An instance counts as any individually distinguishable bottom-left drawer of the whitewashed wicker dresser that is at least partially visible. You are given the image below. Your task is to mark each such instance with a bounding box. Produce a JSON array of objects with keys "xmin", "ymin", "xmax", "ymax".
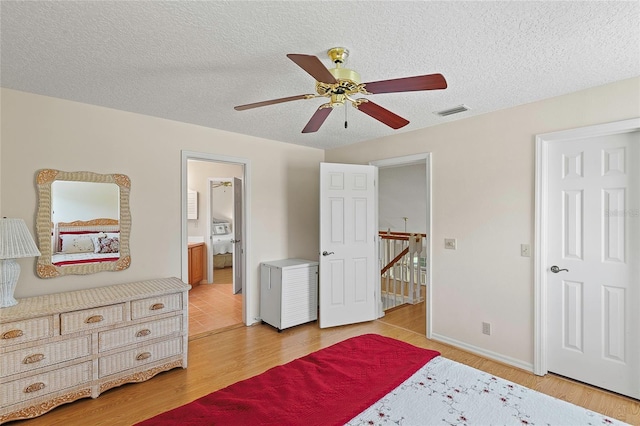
[{"xmin": 0, "ymin": 361, "xmax": 91, "ymax": 407}]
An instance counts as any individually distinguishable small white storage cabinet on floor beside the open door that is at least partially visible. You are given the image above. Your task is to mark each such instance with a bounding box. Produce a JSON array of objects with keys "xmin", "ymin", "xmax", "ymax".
[{"xmin": 260, "ymin": 259, "xmax": 318, "ymax": 332}]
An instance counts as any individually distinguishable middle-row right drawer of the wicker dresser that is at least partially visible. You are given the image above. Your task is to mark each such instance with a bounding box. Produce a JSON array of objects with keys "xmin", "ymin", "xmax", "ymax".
[{"xmin": 98, "ymin": 315, "xmax": 183, "ymax": 352}]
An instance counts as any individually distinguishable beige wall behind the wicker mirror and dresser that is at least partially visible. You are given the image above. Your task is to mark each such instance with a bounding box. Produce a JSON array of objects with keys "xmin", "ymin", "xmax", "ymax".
[{"xmin": 0, "ymin": 89, "xmax": 324, "ymax": 318}]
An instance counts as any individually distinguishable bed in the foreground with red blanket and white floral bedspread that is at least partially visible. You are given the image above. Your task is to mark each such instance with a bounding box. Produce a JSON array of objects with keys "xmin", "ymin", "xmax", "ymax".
[{"xmin": 138, "ymin": 334, "xmax": 625, "ymax": 426}]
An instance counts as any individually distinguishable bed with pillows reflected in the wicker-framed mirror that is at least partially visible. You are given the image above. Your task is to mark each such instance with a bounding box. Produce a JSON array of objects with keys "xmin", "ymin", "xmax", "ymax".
[{"xmin": 51, "ymin": 218, "xmax": 120, "ymax": 266}]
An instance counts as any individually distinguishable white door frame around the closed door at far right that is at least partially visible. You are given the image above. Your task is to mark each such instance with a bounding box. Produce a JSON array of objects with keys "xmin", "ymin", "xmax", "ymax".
[{"xmin": 533, "ymin": 118, "xmax": 640, "ymax": 376}]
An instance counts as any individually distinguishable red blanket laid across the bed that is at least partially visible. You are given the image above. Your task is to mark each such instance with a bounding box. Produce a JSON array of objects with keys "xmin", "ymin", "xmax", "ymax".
[{"xmin": 139, "ymin": 334, "xmax": 440, "ymax": 426}]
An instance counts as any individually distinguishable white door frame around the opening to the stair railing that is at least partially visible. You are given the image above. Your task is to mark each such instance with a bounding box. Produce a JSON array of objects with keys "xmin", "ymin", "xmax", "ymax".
[{"xmin": 369, "ymin": 152, "xmax": 433, "ymax": 339}]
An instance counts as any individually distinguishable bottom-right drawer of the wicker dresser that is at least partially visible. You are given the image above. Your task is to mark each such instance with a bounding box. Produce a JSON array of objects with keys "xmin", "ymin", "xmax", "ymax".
[{"xmin": 98, "ymin": 337, "xmax": 182, "ymax": 378}]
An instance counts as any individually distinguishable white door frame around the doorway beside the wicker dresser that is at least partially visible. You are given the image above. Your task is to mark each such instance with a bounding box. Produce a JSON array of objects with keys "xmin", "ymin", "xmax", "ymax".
[{"xmin": 180, "ymin": 150, "xmax": 253, "ymax": 325}]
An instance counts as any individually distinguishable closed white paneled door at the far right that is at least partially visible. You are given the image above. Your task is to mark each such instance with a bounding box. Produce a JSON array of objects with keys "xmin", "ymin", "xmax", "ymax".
[{"xmin": 545, "ymin": 131, "xmax": 640, "ymax": 398}]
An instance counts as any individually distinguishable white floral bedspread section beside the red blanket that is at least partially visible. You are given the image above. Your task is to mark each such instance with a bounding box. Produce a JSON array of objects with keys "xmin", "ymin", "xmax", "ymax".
[{"xmin": 347, "ymin": 356, "xmax": 626, "ymax": 426}]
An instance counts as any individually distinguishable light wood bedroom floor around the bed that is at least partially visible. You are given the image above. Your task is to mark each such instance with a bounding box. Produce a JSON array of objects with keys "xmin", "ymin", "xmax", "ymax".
[{"xmin": 11, "ymin": 305, "xmax": 640, "ymax": 426}]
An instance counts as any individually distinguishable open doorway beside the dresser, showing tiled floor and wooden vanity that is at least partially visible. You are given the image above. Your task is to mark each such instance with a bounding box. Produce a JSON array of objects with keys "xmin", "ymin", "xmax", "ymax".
[{"xmin": 182, "ymin": 151, "xmax": 249, "ymax": 338}]
